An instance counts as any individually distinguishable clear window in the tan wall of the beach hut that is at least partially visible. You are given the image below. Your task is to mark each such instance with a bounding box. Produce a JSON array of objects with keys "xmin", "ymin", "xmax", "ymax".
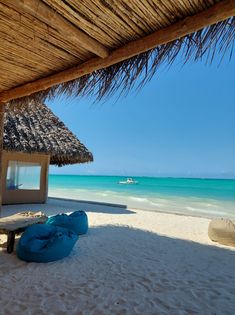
[{"xmin": 6, "ymin": 161, "xmax": 41, "ymax": 190}]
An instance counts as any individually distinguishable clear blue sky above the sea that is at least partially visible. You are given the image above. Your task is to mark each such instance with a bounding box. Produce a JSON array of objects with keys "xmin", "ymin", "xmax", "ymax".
[{"xmin": 47, "ymin": 58, "xmax": 235, "ymax": 178}]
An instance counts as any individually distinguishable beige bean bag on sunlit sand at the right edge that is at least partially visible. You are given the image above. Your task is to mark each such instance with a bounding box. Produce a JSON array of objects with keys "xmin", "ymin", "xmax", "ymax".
[{"xmin": 208, "ymin": 219, "xmax": 235, "ymax": 246}]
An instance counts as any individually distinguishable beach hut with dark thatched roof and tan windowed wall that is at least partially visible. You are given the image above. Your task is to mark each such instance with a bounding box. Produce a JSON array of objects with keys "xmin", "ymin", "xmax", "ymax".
[{"xmin": 1, "ymin": 101, "xmax": 93, "ymax": 204}]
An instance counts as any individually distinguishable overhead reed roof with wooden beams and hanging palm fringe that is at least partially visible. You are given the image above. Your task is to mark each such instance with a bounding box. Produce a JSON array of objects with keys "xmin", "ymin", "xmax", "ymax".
[{"xmin": 0, "ymin": 0, "xmax": 235, "ymax": 102}]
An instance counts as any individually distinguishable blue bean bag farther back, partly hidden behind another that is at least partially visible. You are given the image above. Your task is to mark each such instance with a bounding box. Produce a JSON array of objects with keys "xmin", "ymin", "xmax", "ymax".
[{"xmin": 46, "ymin": 211, "xmax": 88, "ymax": 235}]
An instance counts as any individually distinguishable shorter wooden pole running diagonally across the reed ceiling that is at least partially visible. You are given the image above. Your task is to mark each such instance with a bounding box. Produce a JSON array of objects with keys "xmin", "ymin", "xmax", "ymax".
[{"xmin": 4, "ymin": 0, "xmax": 109, "ymax": 58}]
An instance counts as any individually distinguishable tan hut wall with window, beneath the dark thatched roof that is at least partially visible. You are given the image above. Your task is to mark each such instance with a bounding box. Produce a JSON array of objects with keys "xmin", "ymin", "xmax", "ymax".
[{"xmin": 1, "ymin": 151, "xmax": 50, "ymax": 204}]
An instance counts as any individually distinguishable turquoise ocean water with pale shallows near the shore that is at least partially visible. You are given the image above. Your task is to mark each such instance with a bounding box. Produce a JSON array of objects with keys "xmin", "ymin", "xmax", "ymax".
[{"xmin": 49, "ymin": 175, "xmax": 235, "ymax": 218}]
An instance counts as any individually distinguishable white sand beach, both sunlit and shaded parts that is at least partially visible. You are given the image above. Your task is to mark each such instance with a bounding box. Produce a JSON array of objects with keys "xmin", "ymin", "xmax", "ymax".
[{"xmin": 0, "ymin": 200, "xmax": 235, "ymax": 315}]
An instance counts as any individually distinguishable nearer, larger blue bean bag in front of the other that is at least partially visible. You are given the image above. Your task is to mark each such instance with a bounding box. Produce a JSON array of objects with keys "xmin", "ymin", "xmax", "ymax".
[{"xmin": 16, "ymin": 224, "xmax": 78, "ymax": 262}]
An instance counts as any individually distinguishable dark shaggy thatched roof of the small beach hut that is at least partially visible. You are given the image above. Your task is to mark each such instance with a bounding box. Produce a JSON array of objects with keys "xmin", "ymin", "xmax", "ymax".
[{"xmin": 3, "ymin": 101, "xmax": 93, "ymax": 166}]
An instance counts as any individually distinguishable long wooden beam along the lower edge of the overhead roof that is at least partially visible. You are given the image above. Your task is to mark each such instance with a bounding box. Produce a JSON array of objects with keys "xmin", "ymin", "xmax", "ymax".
[{"xmin": 0, "ymin": 0, "xmax": 235, "ymax": 102}]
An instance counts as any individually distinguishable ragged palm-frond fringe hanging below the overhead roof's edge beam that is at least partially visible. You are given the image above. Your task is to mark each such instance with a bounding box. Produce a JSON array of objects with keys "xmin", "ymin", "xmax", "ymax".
[{"xmin": 11, "ymin": 17, "xmax": 235, "ymax": 105}]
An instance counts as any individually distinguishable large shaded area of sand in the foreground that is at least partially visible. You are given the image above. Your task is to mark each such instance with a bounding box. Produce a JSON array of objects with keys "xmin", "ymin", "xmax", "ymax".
[{"xmin": 0, "ymin": 225, "xmax": 235, "ymax": 315}]
